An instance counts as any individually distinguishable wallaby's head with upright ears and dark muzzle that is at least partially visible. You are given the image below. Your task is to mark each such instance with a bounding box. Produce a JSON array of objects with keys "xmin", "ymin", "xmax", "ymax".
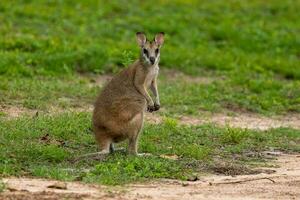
[{"xmin": 136, "ymin": 32, "xmax": 164, "ymax": 65}]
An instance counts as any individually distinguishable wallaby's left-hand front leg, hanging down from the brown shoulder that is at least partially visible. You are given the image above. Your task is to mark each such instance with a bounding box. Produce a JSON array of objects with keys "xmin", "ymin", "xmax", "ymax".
[{"xmin": 134, "ymin": 71, "xmax": 155, "ymax": 112}]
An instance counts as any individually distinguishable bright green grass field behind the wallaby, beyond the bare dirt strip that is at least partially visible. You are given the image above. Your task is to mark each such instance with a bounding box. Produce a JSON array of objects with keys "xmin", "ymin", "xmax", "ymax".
[{"xmin": 0, "ymin": 0, "xmax": 300, "ymax": 115}]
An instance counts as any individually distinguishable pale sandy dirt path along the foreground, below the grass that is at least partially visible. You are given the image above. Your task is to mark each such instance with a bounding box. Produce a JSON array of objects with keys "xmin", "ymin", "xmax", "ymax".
[{"xmin": 0, "ymin": 154, "xmax": 300, "ymax": 200}]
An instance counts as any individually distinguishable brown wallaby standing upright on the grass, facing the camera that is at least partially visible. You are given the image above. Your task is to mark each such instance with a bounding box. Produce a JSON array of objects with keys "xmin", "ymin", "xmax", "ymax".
[{"xmin": 76, "ymin": 32, "xmax": 164, "ymax": 161}]
